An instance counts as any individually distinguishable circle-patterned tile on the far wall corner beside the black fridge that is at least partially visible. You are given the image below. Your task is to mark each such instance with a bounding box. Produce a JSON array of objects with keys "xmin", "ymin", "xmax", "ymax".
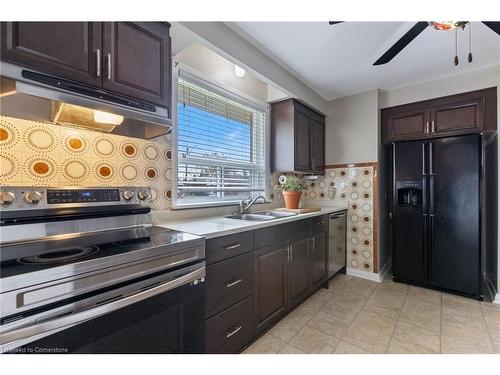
[{"xmin": 304, "ymin": 163, "xmax": 378, "ymax": 272}]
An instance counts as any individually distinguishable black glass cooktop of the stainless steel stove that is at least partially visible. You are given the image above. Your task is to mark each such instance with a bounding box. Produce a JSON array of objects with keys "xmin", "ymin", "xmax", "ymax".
[{"xmin": 0, "ymin": 226, "xmax": 203, "ymax": 279}]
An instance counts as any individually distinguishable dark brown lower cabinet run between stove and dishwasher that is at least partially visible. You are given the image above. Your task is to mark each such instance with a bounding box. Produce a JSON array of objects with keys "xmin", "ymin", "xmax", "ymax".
[{"xmin": 201, "ymin": 216, "xmax": 334, "ymax": 353}]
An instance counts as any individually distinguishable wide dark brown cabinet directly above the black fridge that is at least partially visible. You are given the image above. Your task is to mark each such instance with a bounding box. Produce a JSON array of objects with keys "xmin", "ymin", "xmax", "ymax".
[{"xmin": 381, "ymin": 88, "xmax": 497, "ymax": 143}]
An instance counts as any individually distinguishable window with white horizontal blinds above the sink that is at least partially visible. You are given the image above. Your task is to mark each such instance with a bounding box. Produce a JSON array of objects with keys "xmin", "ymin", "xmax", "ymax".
[{"xmin": 174, "ymin": 71, "xmax": 268, "ymax": 208}]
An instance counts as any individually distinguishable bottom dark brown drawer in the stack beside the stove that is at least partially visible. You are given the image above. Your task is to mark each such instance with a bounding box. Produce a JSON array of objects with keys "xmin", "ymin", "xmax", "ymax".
[{"xmin": 205, "ymin": 295, "xmax": 255, "ymax": 353}]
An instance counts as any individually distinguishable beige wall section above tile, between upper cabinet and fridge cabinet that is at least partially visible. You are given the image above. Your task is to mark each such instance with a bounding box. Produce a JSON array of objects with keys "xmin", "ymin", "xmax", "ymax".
[{"xmin": 325, "ymin": 90, "xmax": 379, "ymax": 164}]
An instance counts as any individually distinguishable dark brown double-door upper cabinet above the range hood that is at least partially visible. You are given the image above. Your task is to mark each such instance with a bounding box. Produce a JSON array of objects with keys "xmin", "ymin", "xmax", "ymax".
[{"xmin": 1, "ymin": 22, "xmax": 171, "ymax": 112}]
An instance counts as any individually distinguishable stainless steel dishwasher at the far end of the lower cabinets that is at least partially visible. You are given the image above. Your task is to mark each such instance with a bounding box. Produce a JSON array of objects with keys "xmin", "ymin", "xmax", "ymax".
[{"xmin": 328, "ymin": 211, "xmax": 347, "ymax": 278}]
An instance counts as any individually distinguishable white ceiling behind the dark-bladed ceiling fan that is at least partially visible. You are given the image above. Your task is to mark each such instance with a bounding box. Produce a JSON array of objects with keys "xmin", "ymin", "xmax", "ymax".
[{"xmin": 227, "ymin": 22, "xmax": 500, "ymax": 100}]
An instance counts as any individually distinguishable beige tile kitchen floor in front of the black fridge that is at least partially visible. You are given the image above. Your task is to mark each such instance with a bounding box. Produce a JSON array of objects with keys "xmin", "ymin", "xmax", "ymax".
[{"xmin": 244, "ymin": 274, "xmax": 500, "ymax": 354}]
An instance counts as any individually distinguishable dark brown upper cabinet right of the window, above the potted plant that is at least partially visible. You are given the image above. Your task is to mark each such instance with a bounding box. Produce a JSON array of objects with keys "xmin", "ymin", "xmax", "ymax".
[{"xmin": 271, "ymin": 99, "xmax": 325, "ymax": 174}]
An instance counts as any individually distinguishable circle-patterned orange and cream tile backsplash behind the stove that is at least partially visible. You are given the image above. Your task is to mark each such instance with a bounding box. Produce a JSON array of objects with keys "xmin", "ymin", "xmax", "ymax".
[{"xmin": 0, "ymin": 116, "xmax": 172, "ymax": 210}]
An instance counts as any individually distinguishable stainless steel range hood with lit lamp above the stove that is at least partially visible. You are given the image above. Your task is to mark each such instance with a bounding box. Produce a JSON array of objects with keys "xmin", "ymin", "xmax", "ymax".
[{"xmin": 0, "ymin": 62, "xmax": 172, "ymax": 139}]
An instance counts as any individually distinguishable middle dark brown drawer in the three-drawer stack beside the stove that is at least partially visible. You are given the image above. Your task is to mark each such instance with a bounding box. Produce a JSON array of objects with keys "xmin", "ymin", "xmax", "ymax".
[{"xmin": 205, "ymin": 252, "xmax": 254, "ymax": 318}]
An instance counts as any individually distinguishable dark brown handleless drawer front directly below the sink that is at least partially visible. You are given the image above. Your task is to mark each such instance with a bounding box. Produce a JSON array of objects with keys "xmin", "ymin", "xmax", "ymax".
[{"xmin": 255, "ymin": 219, "xmax": 311, "ymax": 249}]
